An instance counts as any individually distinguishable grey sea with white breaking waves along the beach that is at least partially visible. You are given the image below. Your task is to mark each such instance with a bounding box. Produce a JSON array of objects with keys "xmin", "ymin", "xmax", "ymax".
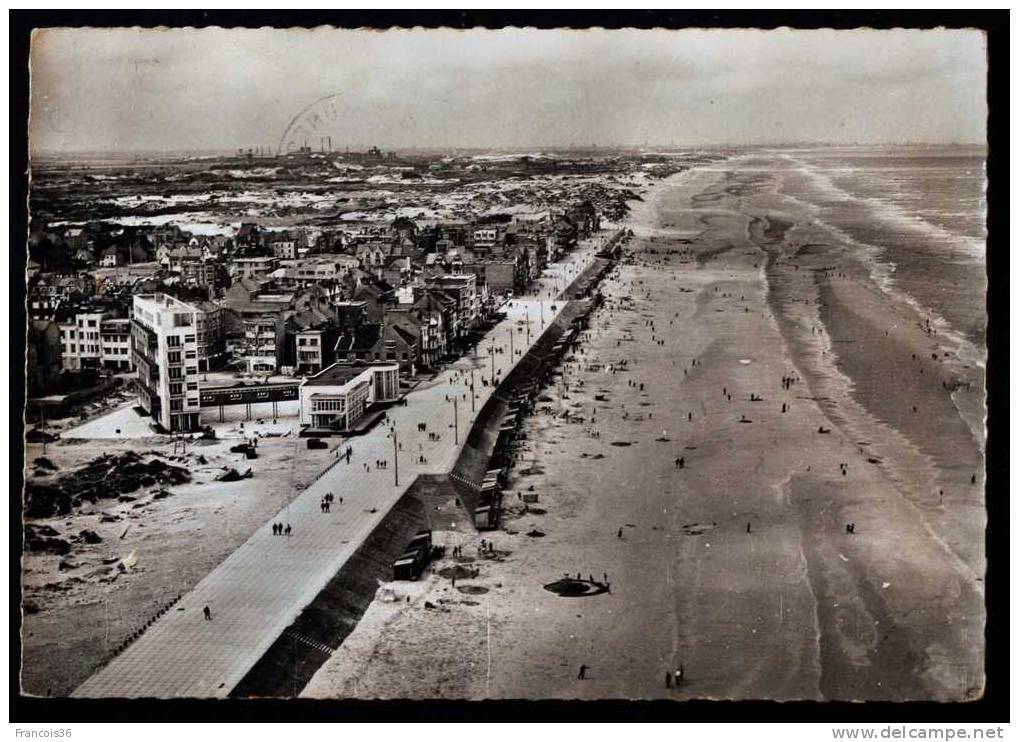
[{"xmin": 776, "ymin": 146, "xmax": 987, "ymax": 359}]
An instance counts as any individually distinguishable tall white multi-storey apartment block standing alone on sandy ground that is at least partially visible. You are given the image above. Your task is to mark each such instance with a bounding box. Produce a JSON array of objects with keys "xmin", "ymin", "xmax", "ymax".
[{"xmin": 131, "ymin": 294, "xmax": 200, "ymax": 431}]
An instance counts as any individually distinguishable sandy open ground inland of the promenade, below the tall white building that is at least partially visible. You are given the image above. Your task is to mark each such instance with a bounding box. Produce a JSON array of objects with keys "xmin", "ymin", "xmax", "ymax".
[{"xmin": 21, "ymin": 404, "xmax": 339, "ymax": 696}]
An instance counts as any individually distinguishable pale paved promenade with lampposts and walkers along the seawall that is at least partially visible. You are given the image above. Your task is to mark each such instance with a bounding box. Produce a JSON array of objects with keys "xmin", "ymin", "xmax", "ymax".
[{"xmin": 72, "ymin": 236, "xmax": 601, "ymax": 698}]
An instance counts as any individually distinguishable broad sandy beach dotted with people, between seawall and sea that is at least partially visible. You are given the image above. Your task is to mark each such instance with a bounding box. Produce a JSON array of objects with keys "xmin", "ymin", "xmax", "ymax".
[{"xmin": 305, "ymin": 161, "xmax": 984, "ymax": 700}]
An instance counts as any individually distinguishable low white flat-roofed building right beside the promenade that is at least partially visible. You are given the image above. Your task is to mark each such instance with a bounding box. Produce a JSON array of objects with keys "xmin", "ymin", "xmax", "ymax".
[{"xmin": 301, "ymin": 363, "xmax": 399, "ymax": 432}]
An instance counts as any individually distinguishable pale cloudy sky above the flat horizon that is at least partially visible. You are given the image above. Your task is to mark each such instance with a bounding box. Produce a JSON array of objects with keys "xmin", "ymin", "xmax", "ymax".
[{"xmin": 30, "ymin": 29, "xmax": 986, "ymax": 153}]
